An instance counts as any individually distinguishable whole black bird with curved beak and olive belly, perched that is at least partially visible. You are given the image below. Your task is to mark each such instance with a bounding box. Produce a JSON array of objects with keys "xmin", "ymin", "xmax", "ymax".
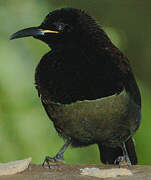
[{"xmin": 10, "ymin": 8, "xmax": 141, "ymax": 165}]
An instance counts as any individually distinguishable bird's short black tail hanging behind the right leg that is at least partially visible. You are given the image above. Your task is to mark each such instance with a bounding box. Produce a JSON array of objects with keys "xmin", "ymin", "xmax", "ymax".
[{"xmin": 98, "ymin": 138, "xmax": 137, "ymax": 165}]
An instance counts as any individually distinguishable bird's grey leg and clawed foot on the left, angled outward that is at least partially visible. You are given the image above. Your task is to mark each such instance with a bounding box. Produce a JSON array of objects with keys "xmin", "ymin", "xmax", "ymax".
[{"xmin": 42, "ymin": 139, "xmax": 71, "ymax": 168}]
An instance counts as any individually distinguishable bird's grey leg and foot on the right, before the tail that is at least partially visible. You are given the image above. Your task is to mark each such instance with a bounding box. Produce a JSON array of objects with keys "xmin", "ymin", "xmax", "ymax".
[{"xmin": 114, "ymin": 143, "xmax": 131, "ymax": 167}]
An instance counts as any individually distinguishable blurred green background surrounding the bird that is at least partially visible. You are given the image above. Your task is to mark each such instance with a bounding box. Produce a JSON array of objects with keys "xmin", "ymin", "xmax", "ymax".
[{"xmin": 0, "ymin": 0, "xmax": 151, "ymax": 165}]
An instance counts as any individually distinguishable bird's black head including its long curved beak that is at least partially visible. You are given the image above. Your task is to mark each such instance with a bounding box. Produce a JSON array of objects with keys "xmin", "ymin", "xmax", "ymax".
[{"xmin": 10, "ymin": 8, "xmax": 100, "ymax": 47}]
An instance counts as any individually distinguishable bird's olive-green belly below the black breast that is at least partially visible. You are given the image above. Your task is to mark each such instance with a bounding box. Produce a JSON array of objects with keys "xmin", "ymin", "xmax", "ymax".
[{"xmin": 45, "ymin": 90, "xmax": 141, "ymax": 146}]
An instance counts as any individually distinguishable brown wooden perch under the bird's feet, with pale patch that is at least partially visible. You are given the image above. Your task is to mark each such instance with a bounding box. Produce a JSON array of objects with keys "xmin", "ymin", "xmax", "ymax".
[{"xmin": 0, "ymin": 164, "xmax": 151, "ymax": 180}]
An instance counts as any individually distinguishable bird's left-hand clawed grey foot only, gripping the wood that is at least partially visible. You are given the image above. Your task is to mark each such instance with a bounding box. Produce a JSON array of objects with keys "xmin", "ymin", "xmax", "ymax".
[{"xmin": 42, "ymin": 154, "xmax": 65, "ymax": 169}]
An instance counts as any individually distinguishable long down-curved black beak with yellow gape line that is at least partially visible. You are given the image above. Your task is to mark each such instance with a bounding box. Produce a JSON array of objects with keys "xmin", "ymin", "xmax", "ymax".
[{"xmin": 10, "ymin": 27, "xmax": 59, "ymax": 40}]
